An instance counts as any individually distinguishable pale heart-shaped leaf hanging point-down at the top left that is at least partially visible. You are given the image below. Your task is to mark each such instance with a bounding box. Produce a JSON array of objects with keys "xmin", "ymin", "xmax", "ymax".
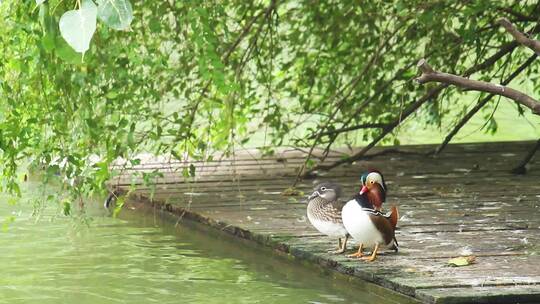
[{"xmin": 60, "ymin": 0, "xmax": 97, "ymax": 54}]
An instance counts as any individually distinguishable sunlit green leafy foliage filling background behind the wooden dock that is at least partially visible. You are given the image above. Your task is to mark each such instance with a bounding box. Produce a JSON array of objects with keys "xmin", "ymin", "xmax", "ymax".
[{"xmin": 0, "ymin": 0, "xmax": 540, "ymax": 204}]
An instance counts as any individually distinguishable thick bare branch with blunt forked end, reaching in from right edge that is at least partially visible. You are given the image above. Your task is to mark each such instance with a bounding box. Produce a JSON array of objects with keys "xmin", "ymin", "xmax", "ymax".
[{"xmin": 416, "ymin": 59, "xmax": 540, "ymax": 115}]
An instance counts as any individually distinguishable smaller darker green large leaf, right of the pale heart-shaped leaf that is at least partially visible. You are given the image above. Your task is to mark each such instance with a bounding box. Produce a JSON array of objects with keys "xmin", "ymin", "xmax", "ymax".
[{"xmin": 98, "ymin": 0, "xmax": 133, "ymax": 30}]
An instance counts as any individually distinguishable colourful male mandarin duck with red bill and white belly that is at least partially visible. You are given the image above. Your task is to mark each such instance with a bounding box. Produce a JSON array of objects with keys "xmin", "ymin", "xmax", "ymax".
[{"xmin": 342, "ymin": 172, "xmax": 399, "ymax": 261}]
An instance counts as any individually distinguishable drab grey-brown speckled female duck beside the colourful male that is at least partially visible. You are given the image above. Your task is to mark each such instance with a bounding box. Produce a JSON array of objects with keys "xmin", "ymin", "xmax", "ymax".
[{"xmin": 307, "ymin": 183, "xmax": 349, "ymax": 254}]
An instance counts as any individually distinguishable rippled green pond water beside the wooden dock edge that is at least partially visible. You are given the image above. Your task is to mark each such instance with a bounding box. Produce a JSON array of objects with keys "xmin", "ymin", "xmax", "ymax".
[{"xmin": 0, "ymin": 191, "xmax": 410, "ymax": 304}]
